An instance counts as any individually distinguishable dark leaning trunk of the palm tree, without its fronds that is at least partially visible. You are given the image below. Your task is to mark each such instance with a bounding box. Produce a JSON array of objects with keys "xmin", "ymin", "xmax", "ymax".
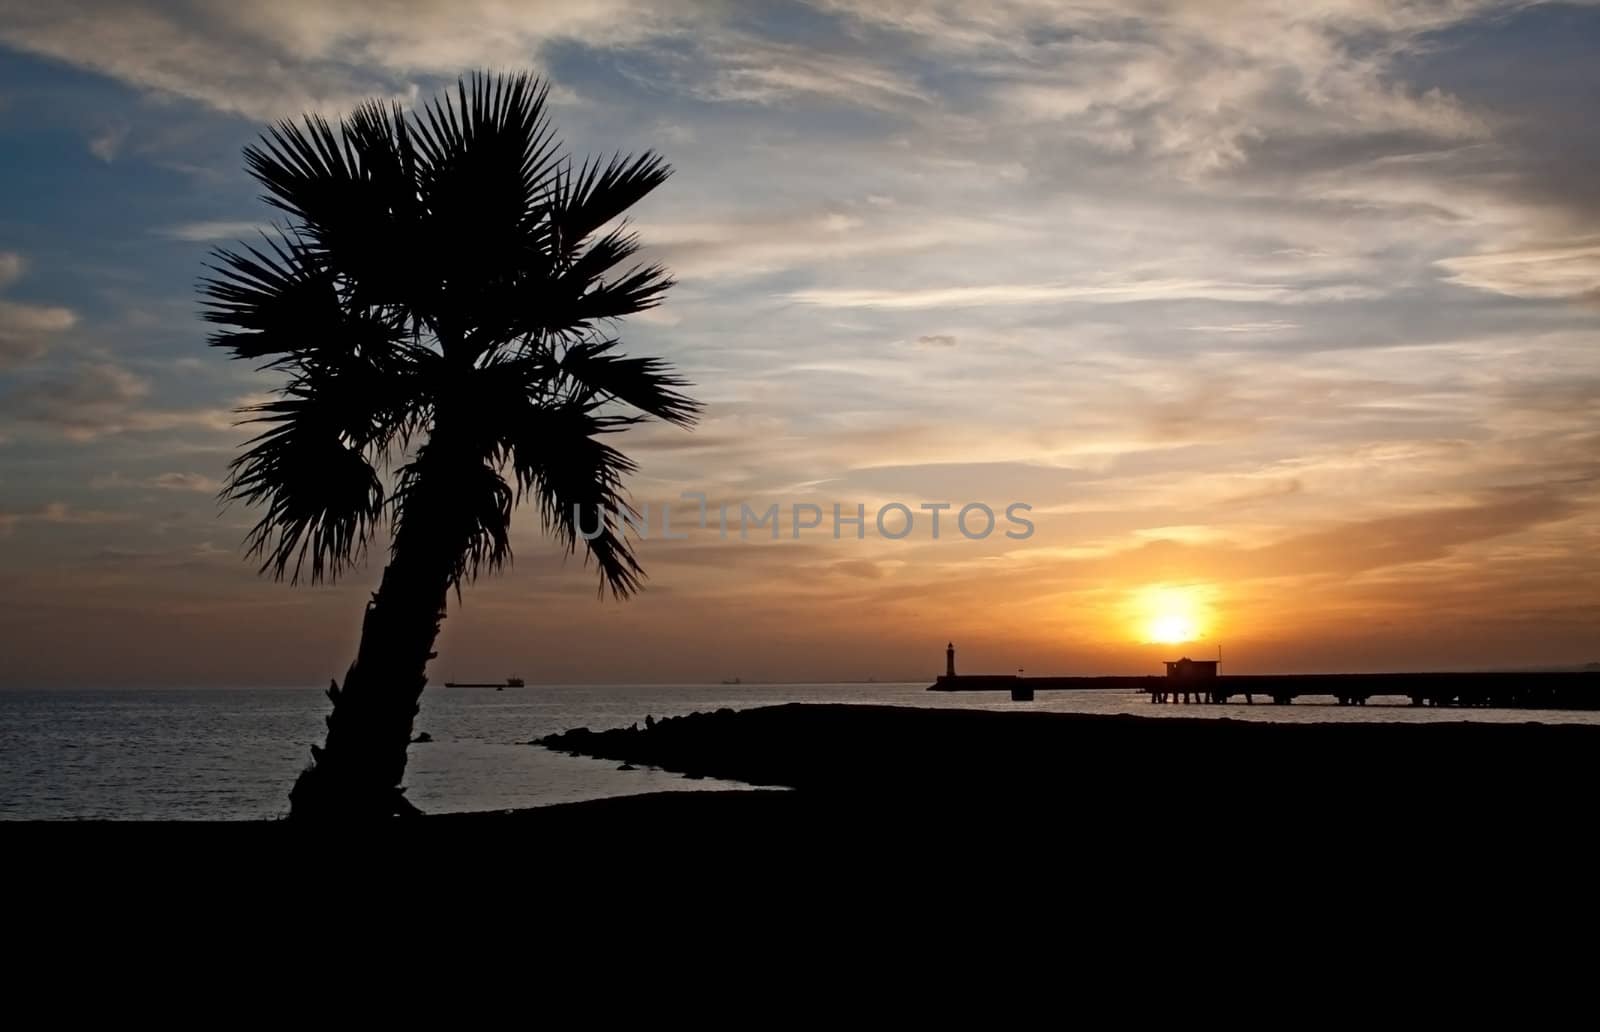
[{"xmin": 290, "ymin": 435, "xmax": 466, "ymax": 819}]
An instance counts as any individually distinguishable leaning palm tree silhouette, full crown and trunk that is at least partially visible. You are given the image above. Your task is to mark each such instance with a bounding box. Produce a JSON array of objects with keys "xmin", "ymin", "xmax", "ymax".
[{"xmin": 200, "ymin": 74, "xmax": 699, "ymax": 818}]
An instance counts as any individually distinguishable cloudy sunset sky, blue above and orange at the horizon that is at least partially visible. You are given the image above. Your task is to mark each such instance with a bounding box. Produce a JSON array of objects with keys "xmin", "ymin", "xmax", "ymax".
[{"xmin": 0, "ymin": 0, "xmax": 1600, "ymax": 686}]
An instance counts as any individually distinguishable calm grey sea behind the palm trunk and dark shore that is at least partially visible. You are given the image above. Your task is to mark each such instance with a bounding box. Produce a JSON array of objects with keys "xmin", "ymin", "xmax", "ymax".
[{"xmin": 0, "ymin": 682, "xmax": 1600, "ymax": 819}]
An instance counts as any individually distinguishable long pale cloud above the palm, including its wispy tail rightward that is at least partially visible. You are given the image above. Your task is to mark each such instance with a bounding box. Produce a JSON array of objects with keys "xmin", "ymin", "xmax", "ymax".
[{"xmin": 0, "ymin": 0, "xmax": 930, "ymax": 122}]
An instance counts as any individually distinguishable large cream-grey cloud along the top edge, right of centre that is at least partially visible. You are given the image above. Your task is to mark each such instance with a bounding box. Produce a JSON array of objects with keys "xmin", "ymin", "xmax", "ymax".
[{"xmin": 800, "ymin": 0, "xmax": 1488, "ymax": 187}]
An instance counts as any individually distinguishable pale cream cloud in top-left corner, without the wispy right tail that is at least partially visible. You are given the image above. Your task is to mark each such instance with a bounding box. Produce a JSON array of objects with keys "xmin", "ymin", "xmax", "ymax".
[{"xmin": 0, "ymin": 0, "xmax": 693, "ymax": 118}]
